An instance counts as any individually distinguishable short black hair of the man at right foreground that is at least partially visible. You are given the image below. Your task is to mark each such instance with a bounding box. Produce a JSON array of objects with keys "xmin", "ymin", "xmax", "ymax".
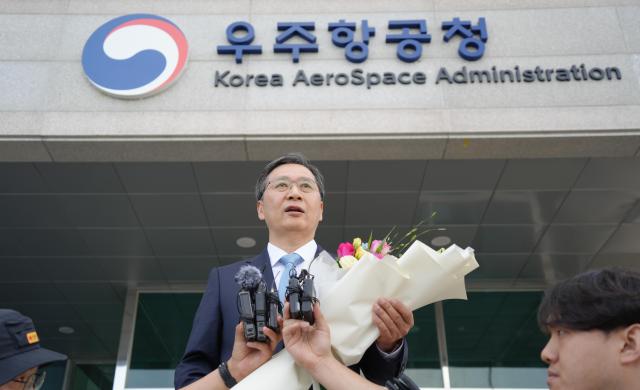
[{"xmin": 538, "ymin": 268, "xmax": 640, "ymax": 332}]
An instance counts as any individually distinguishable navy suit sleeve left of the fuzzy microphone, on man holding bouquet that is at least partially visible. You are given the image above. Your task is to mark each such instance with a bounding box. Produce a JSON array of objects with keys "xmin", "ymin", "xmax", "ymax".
[{"xmin": 174, "ymin": 268, "xmax": 222, "ymax": 389}]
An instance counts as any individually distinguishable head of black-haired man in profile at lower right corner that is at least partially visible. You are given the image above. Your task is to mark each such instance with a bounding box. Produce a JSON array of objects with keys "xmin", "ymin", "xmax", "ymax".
[{"xmin": 538, "ymin": 269, "xmax": 640, "ymax": 390}]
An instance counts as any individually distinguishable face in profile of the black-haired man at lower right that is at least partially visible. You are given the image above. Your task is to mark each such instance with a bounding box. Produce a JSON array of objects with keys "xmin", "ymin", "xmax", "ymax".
[{"xmin": 540, "ymin": 326, "xmax": 620, "ymax": 390}]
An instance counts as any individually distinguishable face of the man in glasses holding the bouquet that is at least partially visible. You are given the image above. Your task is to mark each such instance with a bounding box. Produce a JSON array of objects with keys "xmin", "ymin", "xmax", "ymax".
[{"xmin": 257, "ymin": 164, "xmax": 324, "ymax": 239}]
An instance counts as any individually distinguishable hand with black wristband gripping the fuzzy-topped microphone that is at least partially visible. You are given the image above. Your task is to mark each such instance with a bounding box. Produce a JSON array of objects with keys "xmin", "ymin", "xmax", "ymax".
[{"xmin": 227, "ymin": 317, "xmax": 282, "ymax": 382}]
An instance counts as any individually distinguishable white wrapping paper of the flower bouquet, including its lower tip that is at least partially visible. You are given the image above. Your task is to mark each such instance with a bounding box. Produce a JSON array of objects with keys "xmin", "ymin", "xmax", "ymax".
[{"xmin": 234, "ymin": 241, "xmax": 478, "ymax": 390}]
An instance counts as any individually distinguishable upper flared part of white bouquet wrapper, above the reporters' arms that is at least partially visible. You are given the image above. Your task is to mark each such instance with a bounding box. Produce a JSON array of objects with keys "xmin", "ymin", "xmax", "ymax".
[{"xmin": 321, "ymin": 241, "xmax": 478, "ymax": 365}]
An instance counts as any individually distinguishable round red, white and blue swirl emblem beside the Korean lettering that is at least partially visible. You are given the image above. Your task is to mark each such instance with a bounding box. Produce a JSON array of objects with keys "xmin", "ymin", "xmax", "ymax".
[{"xmin": 82, "ymin": 14, "xmax": 189, "ymax": 98}]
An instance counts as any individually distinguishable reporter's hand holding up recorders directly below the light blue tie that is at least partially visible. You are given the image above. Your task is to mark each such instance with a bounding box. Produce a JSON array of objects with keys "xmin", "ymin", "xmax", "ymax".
[{"xmin": 282, "ymin": 302, "xmax": 332, "ymax": 371}]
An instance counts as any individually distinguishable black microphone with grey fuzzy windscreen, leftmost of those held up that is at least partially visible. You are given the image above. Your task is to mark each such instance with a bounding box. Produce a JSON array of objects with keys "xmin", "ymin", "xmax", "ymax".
[{"xmin": 234, "ymin": 265, "xmax": 264, "ymax": 341}]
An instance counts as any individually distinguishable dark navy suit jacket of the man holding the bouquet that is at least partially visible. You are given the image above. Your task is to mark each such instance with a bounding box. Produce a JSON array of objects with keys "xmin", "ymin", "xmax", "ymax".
[{"xmin": 174, "ymin": 246, "xmax": 408, "ymax": 389}]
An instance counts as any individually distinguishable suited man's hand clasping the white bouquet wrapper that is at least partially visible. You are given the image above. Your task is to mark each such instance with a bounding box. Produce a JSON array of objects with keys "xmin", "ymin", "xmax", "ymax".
[{"xmin": 373, "ymin": 298, "xmax": 413, "ymax": 353}]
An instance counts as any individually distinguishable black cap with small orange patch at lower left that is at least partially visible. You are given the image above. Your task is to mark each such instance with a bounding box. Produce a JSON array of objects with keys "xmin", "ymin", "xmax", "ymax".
[{"xmin": 0, "ymin": 309, "xmax": 67, "ymax": 386}]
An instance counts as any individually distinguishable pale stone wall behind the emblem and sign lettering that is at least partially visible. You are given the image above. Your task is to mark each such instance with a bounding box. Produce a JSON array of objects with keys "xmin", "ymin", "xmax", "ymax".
[{"xmin": 0, "ymin": 0, "xmax": 640, "ymax": 161}]
